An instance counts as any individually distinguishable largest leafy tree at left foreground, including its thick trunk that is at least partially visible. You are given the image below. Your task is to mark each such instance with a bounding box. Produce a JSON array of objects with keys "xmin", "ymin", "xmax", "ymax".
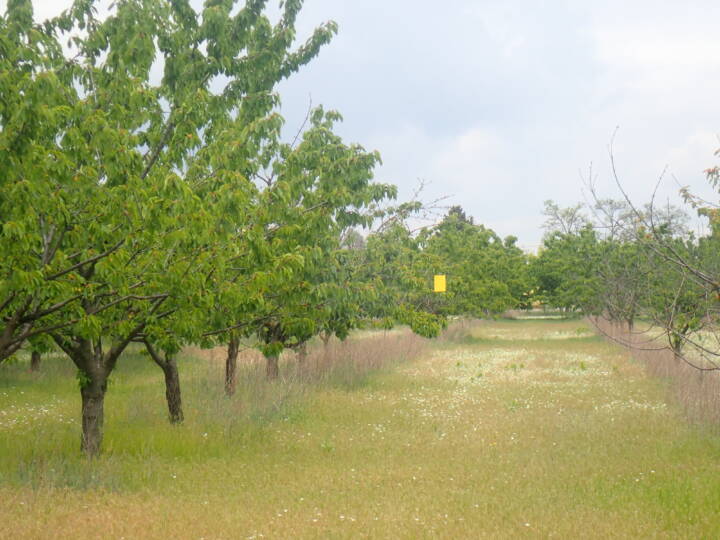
[{"xmin": 0, "ymin": 0, "xmax": 335, "ymax": 455}]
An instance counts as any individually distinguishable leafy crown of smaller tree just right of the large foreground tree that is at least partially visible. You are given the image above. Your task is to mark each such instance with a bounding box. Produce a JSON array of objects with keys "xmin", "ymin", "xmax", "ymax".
[{"xmin": 219, "ymin": 108, "xmax": 395, "ymax": 355}]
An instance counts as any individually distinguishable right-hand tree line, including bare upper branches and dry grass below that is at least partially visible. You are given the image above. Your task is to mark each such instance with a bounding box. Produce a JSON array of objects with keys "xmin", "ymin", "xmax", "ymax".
[{"xmin": 530, "ymin": 154, "xmax": 720, "ymax": 371}]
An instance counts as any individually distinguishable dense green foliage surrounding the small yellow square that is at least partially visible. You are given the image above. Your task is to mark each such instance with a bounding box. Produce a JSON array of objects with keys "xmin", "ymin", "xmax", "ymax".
[{"xmin": 355, "ymin": 207, "xmax": 530, "ymax": 337}]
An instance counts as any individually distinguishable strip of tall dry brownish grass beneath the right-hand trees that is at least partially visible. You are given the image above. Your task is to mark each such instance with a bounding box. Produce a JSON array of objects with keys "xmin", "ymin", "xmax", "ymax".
[{"xmin": 591, "ymin": 318, "xmax": 720, "ymax": 431}]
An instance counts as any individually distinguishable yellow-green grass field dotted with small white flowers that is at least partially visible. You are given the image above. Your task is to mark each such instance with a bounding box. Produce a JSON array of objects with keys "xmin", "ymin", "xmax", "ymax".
[{"xmin": 0, "ymin": 320, "xmax": 720, "ymax": 539}]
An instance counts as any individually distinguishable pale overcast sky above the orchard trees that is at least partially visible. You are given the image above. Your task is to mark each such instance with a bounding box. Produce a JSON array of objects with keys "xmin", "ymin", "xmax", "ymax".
[{"xmin": 15, "ymin": 0, "xmax": 720, "ymax": 248}]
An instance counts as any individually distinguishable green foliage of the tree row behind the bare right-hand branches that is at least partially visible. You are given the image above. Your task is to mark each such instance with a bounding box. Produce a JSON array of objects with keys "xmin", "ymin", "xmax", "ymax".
[{"xmin": 532, "ymin": 200, "xmax": 719, "ymax": 354}]
